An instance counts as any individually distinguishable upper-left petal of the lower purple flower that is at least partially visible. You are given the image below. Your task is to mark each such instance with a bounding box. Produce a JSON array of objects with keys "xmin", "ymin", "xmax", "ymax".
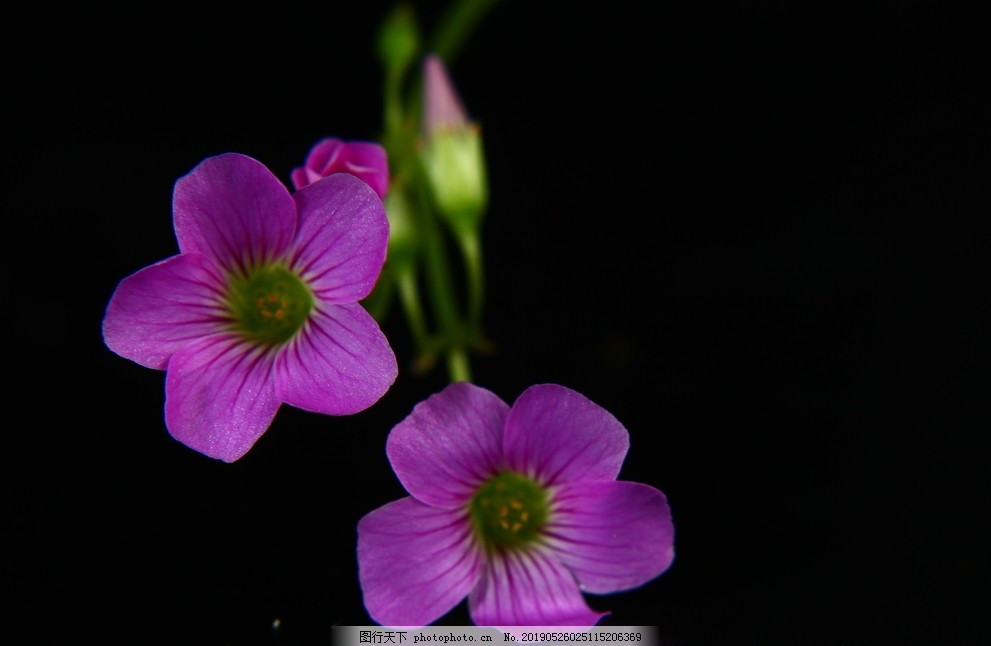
[{"xmin": 385, "ymin": 382, "xmax": 509, "ymax": 509}]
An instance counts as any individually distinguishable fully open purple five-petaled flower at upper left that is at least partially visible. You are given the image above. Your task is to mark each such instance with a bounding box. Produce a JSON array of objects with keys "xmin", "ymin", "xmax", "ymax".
[{"xmin": 103, "ymin": 154, "xmax": 397, "ymax": 462}]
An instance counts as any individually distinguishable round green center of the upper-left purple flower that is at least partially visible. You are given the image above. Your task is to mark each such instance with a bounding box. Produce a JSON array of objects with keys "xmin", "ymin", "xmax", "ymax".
[{"xmin": 227, "ymin": 264, "xmax": 313, "ymax": 345}]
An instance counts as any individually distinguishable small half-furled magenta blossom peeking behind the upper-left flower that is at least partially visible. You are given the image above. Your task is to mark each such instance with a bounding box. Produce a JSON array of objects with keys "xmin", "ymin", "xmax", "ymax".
[{"xmin": 292, "ymin": 138, "xmax": 389, "ymax": 199}]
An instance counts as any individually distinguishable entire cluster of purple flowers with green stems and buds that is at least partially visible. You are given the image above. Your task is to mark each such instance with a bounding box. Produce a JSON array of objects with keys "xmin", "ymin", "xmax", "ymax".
[{"xmin": 103, "ymin": 0, "xmax": 674, "ymax": 627}]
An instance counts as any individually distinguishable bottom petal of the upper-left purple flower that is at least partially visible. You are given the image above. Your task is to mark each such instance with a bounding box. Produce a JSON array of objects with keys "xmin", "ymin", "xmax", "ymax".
[{"xmin": 165, "ymin": 334, "xmax": 280, "ymax": 462}]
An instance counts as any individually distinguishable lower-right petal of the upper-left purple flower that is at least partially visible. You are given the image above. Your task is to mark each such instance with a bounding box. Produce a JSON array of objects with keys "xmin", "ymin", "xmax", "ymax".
[{"xmin": 275, "ymin": 303, "xmax": 398, "ymax": 415}]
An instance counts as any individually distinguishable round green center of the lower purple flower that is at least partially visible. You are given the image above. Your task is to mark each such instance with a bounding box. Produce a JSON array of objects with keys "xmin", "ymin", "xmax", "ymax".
[{"xmin": 469, "ymin": 471, "xmax": 550, "ymax": 550}]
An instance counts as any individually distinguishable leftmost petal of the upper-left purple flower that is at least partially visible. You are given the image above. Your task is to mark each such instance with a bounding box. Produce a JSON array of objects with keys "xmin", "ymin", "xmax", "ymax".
[{"xmin": 103, "ymin": 254, "xmax": 224, "ymax": 370}]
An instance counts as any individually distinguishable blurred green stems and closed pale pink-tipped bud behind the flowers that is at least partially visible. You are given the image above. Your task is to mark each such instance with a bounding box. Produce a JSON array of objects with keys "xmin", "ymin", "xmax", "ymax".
[{"xmin": 370, "ymin": 0, "xmax": 496, "ymax": 382}]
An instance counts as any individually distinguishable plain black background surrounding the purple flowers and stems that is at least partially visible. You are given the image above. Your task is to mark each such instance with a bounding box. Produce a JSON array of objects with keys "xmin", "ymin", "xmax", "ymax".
[{"xmin": 11, "ymin": 1, "xmax": 991, "ymax": 646}]
